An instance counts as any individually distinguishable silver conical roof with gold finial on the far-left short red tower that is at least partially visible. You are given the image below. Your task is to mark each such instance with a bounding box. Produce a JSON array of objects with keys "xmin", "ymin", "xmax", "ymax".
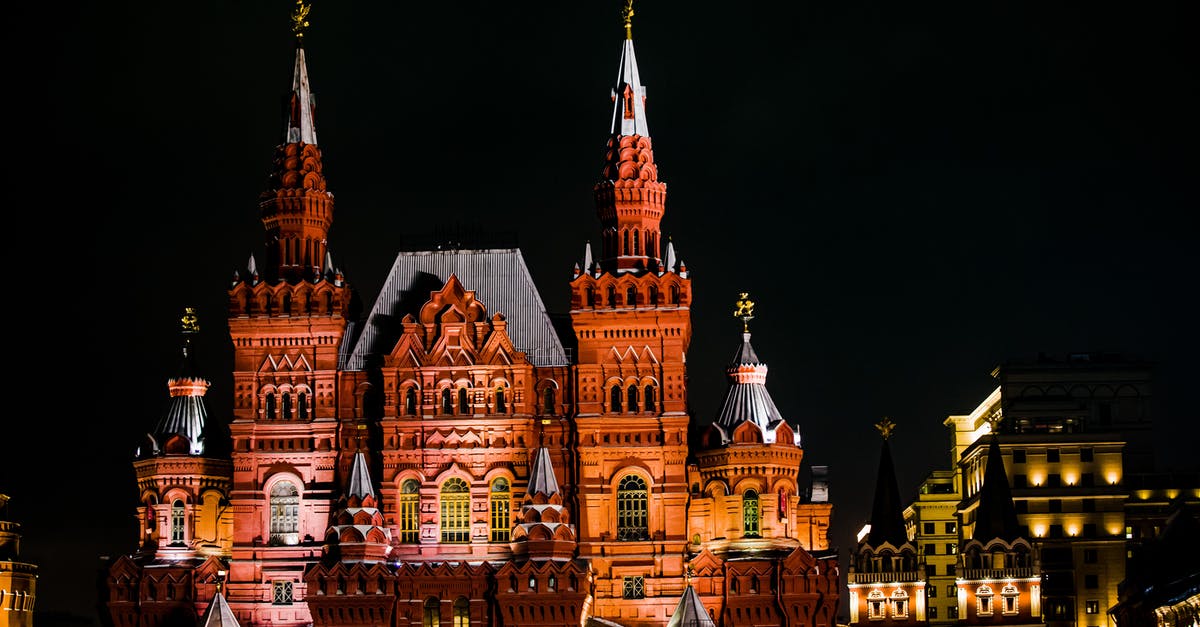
[{"xmin": 142, "ymin": 307, "xmax": 210, "ymax": 455}]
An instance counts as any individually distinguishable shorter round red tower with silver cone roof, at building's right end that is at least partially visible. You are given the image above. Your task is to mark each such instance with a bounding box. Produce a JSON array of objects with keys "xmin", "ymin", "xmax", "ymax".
[{"xmin": 688, "ymin": 293, "xmax": 839, "ymax": 626}]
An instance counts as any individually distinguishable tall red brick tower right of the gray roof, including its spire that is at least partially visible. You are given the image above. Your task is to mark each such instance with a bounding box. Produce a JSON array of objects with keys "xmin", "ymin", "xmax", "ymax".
[{"xmin": 570, "ymin": 0, "xmax": 691, "ymax": 625}]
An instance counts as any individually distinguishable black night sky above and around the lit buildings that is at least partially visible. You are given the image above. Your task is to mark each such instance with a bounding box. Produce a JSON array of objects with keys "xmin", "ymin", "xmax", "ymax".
[{"xmin": 11, "ymin": 0, "xmax": 1200, "ymax": 614}]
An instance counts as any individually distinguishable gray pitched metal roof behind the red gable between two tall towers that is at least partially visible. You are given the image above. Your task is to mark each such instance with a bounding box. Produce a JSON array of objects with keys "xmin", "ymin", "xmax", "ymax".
[{"xmin": 341, "ymin": 249, "xmax": 569, "ymax": 370}]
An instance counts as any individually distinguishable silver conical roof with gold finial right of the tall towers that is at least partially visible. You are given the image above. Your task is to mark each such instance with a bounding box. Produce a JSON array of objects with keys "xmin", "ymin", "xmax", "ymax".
[{"xmin": 710, "ymin": 292, "xmax": 800, "ymax": 446}]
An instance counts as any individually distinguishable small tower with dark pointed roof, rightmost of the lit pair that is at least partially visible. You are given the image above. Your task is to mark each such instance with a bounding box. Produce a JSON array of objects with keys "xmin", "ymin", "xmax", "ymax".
[{"xmin": 958, "ymin": 417, "xmax": 1043, "ymax": 625}]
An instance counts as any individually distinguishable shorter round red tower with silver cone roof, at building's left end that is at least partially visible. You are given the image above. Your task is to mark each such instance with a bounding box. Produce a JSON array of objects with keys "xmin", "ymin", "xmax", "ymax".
[{"xmin": 108, "ymin": 307, "xmax": 233, "ymax": 627}]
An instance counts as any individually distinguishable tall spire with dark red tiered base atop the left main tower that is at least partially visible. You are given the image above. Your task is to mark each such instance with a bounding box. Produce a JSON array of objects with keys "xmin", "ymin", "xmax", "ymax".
[{"xmin": 259, "ymin": 0, "xmax": 334, "ymax": 282}]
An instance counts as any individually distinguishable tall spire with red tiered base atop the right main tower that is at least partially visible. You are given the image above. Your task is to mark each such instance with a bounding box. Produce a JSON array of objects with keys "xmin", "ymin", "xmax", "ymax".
[{"xmin": 593, "ymin": 0, "xmax": 667, "ymax": 273}]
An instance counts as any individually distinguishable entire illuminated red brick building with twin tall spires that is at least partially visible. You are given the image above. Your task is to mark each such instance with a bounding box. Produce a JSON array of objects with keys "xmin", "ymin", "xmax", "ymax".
[{"xmin": 108, "ymin": 4, "xmax": 839, "ymax": 627}]
